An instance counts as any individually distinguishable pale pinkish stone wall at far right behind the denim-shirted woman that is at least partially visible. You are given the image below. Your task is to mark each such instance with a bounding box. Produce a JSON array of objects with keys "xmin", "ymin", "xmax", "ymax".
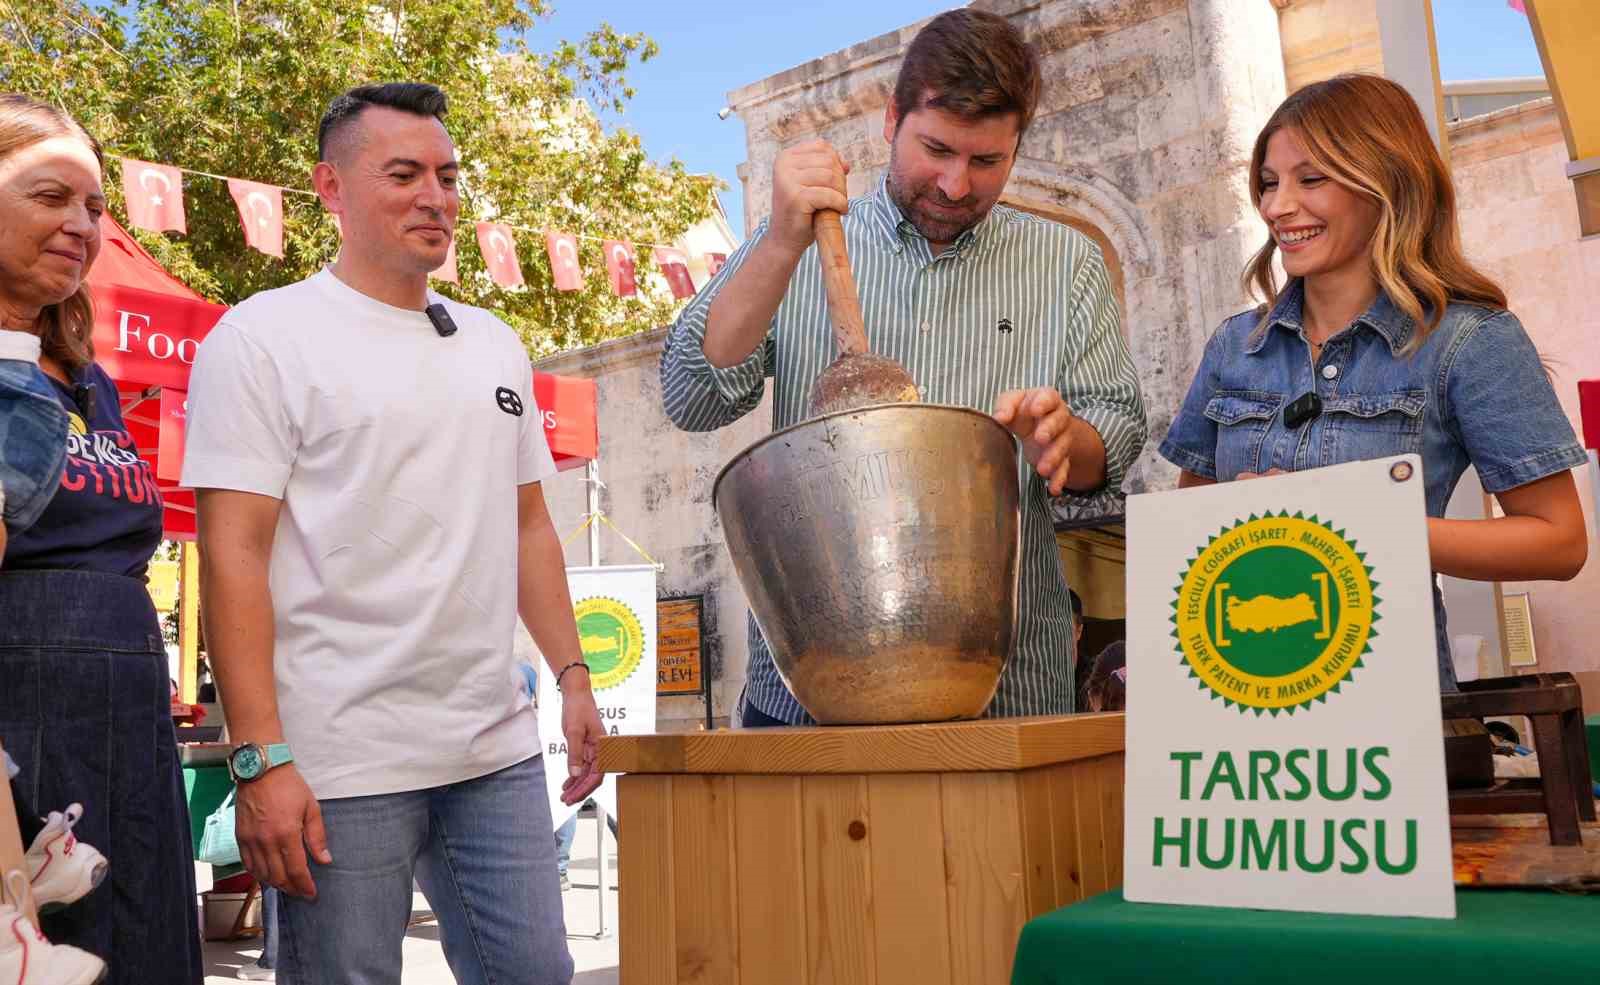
[{"xmin": 1450, "ymin": 99, "xmax": 1600, "ymax": 672}]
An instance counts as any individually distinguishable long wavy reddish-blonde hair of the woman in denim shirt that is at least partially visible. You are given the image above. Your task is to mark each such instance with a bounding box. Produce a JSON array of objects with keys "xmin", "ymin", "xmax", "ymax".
[{"xmin": 1243, "ymin": 75, "xmax": 1506, "ymax": 352}]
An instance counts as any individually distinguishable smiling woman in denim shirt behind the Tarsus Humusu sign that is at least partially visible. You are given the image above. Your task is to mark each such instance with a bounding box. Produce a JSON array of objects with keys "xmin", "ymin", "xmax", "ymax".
[{"xmin": 1162, "ymin": 75, "xmax": 1589, "ymax": 691}]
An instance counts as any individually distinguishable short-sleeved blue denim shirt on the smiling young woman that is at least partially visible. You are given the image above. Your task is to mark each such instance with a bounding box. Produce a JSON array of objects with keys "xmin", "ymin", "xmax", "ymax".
[{"xmin": 1160, "ymin": 280, "xmax": 1586, "ymax": 691}]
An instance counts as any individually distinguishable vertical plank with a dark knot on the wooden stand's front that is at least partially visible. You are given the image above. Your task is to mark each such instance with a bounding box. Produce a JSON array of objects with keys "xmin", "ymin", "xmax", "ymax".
[{"xmin": 800, "ymin": 776, "xmax": 877, "ymax": 985}]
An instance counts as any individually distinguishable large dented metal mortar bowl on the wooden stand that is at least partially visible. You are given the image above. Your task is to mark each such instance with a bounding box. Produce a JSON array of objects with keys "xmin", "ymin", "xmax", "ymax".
[{"xmin": 712, "ymin": 403, "xmax": 1021, "ymax": 724}]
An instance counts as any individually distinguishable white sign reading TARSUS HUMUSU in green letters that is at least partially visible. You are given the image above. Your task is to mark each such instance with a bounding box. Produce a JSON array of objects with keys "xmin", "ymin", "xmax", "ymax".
[{"xmin": 1125, "ymin": 456, "xmax": 1456, "ymax": 916}]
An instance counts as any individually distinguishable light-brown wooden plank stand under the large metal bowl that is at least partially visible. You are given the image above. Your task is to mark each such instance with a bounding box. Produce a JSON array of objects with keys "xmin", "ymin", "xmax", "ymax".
[{"xmin": 600, "ymin": 713, "xmax": 1123, "ymax": 985}]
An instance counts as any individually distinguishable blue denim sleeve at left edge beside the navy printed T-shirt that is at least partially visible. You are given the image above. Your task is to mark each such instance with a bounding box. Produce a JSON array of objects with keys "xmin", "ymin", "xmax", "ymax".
[{"xmin": 0, "ymin": 358, "xmax": 67, "ymax": 534}]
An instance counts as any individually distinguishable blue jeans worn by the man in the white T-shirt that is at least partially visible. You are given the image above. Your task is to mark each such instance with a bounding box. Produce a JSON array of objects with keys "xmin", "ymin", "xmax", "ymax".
[{"xmin": 277, "ymin": 756, "xmax": 573, "ymax": 985}]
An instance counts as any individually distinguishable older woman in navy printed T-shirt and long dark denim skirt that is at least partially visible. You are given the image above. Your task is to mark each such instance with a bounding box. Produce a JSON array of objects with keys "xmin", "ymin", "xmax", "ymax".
[{"xmin": 0, "ymin": 96, "xmax": 203, "ymax": 985}]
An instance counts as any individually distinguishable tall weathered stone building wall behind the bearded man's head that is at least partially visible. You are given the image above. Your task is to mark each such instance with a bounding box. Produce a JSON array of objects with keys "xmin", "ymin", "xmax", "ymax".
[{"xmin": 730, "ymin": 0, "xmax": 1283, "ymax": 491}]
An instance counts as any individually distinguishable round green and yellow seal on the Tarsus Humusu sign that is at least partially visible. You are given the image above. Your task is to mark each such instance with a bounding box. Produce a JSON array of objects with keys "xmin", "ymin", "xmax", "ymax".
[{"xmin": 1171, "ymin": 512, "xmax": 1381, "ymax": 715}]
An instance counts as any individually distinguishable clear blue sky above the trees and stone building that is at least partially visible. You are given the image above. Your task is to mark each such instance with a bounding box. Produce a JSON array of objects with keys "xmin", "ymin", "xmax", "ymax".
[{"xmin": 530, "ymin": 0, "xmax": 1541, "ymax": 232}]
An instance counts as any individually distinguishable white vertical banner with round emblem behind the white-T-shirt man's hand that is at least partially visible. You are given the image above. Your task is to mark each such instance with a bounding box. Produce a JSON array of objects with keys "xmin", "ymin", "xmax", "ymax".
[{"xmin": 539, "ymin": 564, "xmax": 656, "ymax": 828}]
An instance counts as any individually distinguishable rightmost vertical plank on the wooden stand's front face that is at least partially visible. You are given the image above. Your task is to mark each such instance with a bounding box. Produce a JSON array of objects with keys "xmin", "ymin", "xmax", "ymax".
[{"xmin": 939, "ymin": 772, "xmax": 1027, "ymax": 985}]
